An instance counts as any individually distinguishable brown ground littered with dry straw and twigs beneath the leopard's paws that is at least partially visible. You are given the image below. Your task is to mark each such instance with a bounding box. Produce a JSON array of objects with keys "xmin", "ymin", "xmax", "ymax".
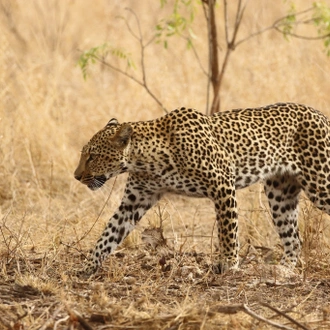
[{"xmin": 0, "ymin": 222, "xmax": 330, "ymax": 329}]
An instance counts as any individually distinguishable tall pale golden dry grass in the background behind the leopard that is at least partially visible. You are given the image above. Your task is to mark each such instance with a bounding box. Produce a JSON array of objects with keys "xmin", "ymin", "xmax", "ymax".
[{"xmin": 0, "ymin": 0, "xmax": 330, "ymax": 282}]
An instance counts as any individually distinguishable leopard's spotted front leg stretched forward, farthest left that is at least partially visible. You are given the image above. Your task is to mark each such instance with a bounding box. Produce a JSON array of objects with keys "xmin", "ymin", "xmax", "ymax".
[{"xmin": 83, "ymin": 178, "xmax": 161, "ymax": 275}]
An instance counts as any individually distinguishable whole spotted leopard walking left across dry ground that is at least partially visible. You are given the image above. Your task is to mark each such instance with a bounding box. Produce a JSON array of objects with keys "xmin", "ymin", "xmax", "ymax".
[{"xmin": 74, "ymin": 103, "xmax": 330, "ymax": 274}]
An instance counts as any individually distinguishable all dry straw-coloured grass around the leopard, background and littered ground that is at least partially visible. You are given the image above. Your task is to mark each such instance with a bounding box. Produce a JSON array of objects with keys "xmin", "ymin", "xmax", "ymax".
[{"xmin": 0, "ymin": 0, "xmax": 330, "ymax": 329}]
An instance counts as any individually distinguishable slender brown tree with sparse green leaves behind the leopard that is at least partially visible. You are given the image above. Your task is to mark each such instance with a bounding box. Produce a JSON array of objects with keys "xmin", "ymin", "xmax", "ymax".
[{"xmin": 79, "ymin": 0, "xmax": 330, "ymax": 114}]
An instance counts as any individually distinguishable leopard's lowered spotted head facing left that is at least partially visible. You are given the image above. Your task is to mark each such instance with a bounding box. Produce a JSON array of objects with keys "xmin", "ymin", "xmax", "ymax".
[{"xmin": 74, "ymin": 118, "xmax": 133, "ymax": 190}]
